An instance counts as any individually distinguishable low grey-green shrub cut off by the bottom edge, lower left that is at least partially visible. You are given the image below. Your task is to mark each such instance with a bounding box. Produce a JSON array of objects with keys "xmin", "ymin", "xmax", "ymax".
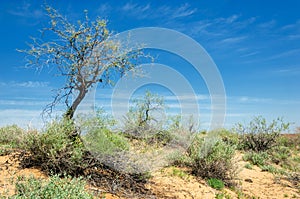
[{"xmin": 10, "ymin": 175, "xmax": 93, "ymax": 199}]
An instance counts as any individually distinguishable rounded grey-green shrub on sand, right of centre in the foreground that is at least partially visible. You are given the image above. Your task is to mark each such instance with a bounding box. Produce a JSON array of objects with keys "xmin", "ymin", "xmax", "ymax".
[{"xmin": 189, "ymin": 136, "xmax": 236, "ymax": 183}]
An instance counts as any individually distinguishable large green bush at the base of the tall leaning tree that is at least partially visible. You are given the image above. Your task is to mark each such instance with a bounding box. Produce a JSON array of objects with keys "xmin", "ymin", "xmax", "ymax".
[{"xmin": 23, "ymin": 120, "xmax": 86, "ymax": 175}]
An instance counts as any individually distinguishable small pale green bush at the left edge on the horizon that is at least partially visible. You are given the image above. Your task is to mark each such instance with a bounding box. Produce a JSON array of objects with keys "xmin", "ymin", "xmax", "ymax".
[{"xmin": 0, "ymin": 124, "xmax": 25, "ymax": 147}]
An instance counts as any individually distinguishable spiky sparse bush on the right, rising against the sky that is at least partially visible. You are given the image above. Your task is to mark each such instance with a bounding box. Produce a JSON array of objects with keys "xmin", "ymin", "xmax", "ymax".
[{"xmin": 234, "ymin": 116, "xmax": 289, "ymax": 152}]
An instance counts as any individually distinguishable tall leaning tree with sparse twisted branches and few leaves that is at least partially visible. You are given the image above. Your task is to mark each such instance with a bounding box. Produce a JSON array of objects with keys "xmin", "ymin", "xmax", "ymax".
[{"xmin": 21, "ymin": 6, "xmax": 143, "ymax": 119}]
